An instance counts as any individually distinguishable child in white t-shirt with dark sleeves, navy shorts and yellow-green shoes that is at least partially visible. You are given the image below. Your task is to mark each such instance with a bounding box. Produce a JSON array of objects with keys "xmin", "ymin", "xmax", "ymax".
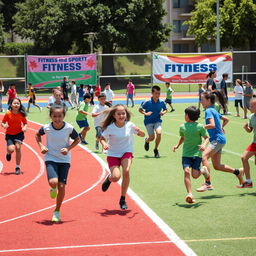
[{"xmin": 36, "ymin": 105, "xmax": 79, "ymax": 222}]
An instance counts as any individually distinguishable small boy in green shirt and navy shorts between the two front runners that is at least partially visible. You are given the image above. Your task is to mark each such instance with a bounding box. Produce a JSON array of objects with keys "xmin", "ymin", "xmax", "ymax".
[{"xmin": 76, "ymin": 93, "xmax": 92, "ymax": 144}]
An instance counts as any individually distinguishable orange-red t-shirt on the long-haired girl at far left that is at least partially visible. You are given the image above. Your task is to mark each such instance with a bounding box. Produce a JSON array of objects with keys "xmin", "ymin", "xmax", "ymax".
[{"xmin": 2, "ymin": 111, "xmax": 27, "ymax": 135}]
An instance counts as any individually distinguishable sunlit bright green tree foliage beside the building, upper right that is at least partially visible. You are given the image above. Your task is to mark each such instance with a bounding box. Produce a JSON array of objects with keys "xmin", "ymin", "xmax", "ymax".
[{"xmin": 187, "ymin": 0, "xmax": 256, "ymax": 48}]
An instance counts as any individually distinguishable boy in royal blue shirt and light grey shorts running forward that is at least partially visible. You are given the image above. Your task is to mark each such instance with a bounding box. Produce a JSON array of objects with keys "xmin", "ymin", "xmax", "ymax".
[{"xmin": 139, "ymin": 85, "xmax": 167, "ymax": 158}]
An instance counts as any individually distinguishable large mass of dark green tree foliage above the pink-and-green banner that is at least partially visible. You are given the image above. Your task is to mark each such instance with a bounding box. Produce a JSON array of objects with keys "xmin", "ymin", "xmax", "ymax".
[{"xmin": 14, "ymin": 0, "xmax": 171, "ymax": 53}]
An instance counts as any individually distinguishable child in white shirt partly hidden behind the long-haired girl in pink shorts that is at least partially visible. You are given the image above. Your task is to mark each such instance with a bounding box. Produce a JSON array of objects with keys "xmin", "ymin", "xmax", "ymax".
[{"xmin": 92, "ymin": 93, "xmax": 108, "ymax": 150}]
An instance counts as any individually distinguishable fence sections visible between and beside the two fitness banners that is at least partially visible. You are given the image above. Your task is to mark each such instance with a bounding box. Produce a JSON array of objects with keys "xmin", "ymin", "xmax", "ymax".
[{"xmin": 0, "ymin": 51, "xmax": 256, "ymax": 92}]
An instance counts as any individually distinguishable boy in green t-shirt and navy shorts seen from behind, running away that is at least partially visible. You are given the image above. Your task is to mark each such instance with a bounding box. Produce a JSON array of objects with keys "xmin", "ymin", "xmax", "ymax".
[{"xmin": 173, "ymin": 106, "xmax": 209, "ymax": 204}]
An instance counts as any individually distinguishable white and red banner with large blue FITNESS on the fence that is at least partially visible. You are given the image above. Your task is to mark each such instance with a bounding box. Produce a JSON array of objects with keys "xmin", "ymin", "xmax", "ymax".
[{"xmin": 153, "ymin": 52, "xmax": 233, "ymax": 84}]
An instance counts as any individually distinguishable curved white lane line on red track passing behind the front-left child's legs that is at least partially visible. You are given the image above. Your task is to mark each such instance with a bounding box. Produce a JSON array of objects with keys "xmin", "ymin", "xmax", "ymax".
[{"xmin": 0, "ymin": 126, "xmax": 106, "ymax": 225}]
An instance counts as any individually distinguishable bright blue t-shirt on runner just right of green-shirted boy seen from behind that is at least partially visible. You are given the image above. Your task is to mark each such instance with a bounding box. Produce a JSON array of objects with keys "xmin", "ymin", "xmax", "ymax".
[{"xmin": 205, "ymin": 106, "xmax": 226, "ymax": 144}]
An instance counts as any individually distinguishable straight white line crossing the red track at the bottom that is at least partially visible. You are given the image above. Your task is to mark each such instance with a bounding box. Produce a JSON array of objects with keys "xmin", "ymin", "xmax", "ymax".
[{"xmin": 0, "ymin": 240, "xmax": 173, "ymax": 253}]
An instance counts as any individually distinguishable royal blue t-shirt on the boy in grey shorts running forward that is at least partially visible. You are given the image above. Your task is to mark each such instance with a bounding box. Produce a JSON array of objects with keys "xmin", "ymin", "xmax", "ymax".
[{"xmin": 140, "ymin": 98, "xmax": 166, "ymax": 125}]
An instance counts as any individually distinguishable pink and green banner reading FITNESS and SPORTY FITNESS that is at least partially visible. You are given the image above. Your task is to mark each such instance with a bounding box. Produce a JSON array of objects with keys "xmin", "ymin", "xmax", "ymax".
[{"xmin": 27, "ymin": 54, "xmax": 97, "ymax": 88}]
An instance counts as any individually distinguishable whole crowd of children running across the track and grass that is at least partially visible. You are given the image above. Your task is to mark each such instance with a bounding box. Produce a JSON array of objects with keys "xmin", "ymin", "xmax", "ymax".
[{"xmin": 0, "ymin": 71, "xmax": 256, "ymax": 221}]
